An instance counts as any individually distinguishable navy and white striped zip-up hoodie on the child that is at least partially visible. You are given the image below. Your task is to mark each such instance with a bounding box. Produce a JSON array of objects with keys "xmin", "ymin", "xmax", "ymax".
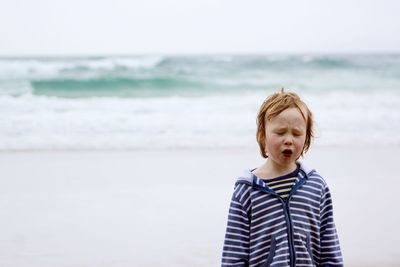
[{"xmin": 222, "ymin": 165, "xmax": 343, "ymax": 267}]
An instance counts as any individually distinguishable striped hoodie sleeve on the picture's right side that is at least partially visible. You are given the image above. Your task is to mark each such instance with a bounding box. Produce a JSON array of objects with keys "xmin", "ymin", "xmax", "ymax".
[{"xmin": 317, "ymin": 185, "xmax": 343, "ymax": 267}]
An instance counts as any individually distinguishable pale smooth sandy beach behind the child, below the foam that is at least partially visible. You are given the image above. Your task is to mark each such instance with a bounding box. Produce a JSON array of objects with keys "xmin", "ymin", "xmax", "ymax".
[{"xmin": 0, "ymin": 146, "xmax": 400, "ymax": 267}]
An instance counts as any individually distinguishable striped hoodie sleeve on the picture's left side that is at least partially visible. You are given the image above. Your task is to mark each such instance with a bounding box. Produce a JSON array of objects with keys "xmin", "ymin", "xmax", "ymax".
[{"xmin": 221, "ymin": 188, "xmax": 250, "ymax": 267}]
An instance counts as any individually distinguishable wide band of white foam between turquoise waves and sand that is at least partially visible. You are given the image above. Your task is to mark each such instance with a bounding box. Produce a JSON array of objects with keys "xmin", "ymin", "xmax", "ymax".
[{"xmin": 0, "ymin": 92, "xmax": 400, "ymax": 150}]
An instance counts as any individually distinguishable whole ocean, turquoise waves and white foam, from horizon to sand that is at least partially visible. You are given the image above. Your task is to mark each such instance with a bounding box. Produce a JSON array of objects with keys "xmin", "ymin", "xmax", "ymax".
[{"xmin": 0, "ymin": 55, "xmax": 400, "ymax": 151}]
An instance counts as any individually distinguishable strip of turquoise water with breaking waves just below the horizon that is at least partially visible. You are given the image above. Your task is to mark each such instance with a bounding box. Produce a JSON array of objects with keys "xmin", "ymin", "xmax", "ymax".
[{"xmin": 0, "ymin": 55, "xmax": 400, "ymax": 98}]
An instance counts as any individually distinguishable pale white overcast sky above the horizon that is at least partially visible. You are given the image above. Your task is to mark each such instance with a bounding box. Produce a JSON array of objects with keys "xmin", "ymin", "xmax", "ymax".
[{"xmin": 0, "ymin": 0, "xmax": 400, "ymax": 56}]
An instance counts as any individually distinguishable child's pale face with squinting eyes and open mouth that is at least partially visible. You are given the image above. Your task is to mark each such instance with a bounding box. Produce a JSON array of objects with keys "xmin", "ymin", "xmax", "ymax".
[{"xmin": 265, "ymin": 108, "xmax": 307, "ymax": 167}]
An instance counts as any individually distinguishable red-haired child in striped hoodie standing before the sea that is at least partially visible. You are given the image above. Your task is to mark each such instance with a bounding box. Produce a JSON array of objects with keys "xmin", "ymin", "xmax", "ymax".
[{"xmin": 222, "ymin": 89, "xmax": 343, "ymax": 267}]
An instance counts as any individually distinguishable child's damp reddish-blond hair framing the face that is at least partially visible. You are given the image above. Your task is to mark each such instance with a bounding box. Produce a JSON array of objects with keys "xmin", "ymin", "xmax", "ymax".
[{"xmin": 256, "ymin": 88, "xmax": 314, "ymax": 158}]
